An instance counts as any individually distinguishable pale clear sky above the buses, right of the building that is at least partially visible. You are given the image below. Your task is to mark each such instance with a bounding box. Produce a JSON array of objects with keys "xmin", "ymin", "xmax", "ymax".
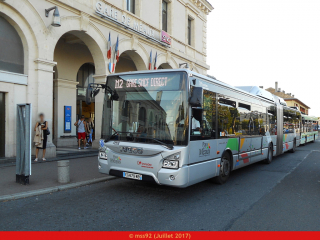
[{"xmin": 207, "ymin": 0, "xmax": 320, "ymax": 116}]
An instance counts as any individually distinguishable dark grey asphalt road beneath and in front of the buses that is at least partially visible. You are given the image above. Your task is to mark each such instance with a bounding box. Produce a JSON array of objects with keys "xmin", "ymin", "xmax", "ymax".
[{"xmin": 0, "ymin": 141, "xmax": 320, "ymax": 231}]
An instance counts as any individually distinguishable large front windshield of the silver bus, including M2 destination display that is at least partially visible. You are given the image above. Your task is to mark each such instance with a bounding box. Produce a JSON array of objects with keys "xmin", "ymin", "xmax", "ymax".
[{"xmin": 101, "ymin": 71, "xmax": 188, "ymax": 145}]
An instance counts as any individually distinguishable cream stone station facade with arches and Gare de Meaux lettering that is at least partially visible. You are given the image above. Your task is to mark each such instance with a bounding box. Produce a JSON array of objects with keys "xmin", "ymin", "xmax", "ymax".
[{"xmin": 0, "ymin": 0, "xmax": 213, "ymax": 157}]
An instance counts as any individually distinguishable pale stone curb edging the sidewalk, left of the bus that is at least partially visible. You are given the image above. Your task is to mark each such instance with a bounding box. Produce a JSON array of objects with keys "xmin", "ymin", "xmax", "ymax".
[{"xmin": 0, "ymin": 176, "xmax": 116, "ymax": 202}]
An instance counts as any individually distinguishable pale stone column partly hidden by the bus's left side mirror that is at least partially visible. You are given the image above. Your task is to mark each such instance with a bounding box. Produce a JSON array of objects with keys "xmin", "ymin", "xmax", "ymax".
[{"xmin": 92, "ymin": 75, "xmax": 107, "ymax": 148}]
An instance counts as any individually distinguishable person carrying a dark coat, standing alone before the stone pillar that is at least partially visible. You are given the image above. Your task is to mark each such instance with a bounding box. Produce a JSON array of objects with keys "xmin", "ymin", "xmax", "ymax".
[{"xmin": 34, "ymin": 113, "xmax": 48, "ymax": 162}]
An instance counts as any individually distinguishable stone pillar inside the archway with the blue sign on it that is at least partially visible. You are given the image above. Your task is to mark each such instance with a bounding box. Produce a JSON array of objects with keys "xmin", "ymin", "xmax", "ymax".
[{"xmin": 53, "ymin": 78, "xmax": 79, "ymax": 147}]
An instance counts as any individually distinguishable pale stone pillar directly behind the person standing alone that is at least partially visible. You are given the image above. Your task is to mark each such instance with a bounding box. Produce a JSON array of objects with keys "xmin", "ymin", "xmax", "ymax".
[{"xmin": 33, "ymin": 58, "xmax": 57, "ymax": 158}]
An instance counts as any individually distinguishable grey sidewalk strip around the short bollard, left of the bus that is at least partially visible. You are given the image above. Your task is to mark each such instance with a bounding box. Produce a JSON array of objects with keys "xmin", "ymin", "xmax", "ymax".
[{"xmin": 0, "ymin": 156, "xmax": 114, "ymax": 201}]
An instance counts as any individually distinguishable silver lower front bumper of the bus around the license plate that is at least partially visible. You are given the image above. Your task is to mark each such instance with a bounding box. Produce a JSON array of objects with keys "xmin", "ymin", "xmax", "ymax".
[{"xmin": 98, "ymin": 158, "xmax": 189, "ymax": 188}]
